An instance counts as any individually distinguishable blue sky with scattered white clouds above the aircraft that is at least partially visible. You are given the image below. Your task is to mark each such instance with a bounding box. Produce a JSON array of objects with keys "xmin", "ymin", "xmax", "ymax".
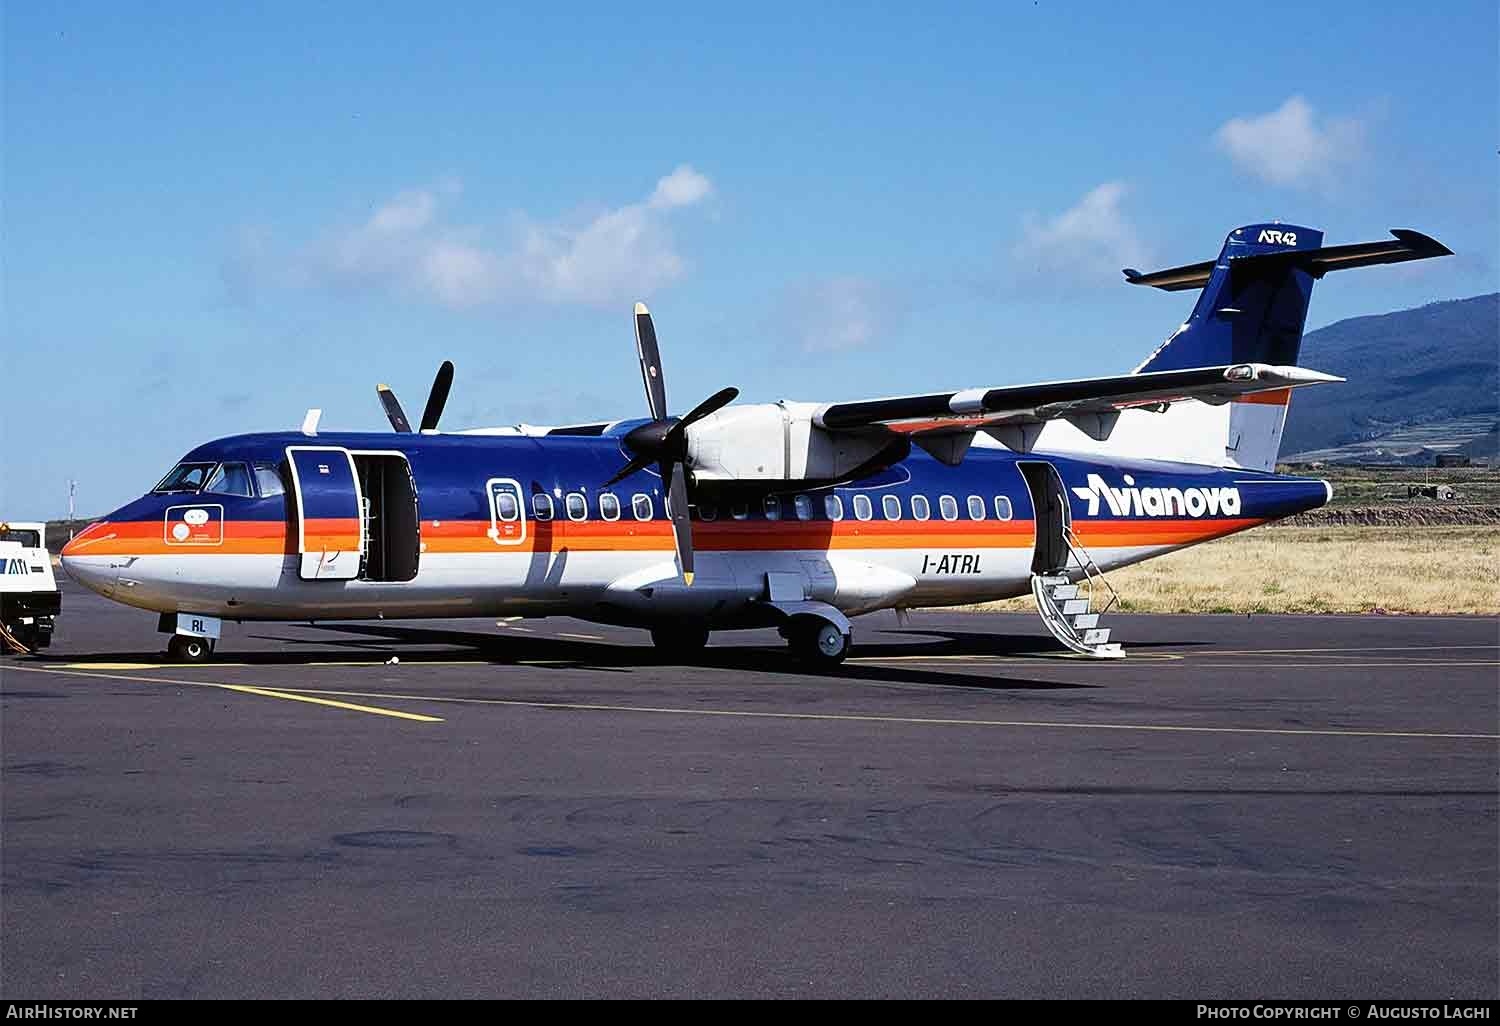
[{"xmin": 0, "ymin": 0, "xmax": 1500, "ymax": 518}]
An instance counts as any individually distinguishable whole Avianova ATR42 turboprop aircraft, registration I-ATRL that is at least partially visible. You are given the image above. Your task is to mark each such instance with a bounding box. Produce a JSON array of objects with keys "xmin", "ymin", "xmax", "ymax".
[{"xmin": 63, "ymin": 224, "xmax": 1451, "ymax": 665}]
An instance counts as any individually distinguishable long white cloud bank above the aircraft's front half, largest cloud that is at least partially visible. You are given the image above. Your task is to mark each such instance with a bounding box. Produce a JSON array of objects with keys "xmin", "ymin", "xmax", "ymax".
[{"xmin": 246, "ymin": 164, "xmax": 713, "ymax": 308}]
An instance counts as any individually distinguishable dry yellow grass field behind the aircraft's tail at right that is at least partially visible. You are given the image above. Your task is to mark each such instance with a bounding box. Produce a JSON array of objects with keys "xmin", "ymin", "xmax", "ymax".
[{"xmin": 975, "ymin": 527, "xmax": 1500, "ymax": 615}]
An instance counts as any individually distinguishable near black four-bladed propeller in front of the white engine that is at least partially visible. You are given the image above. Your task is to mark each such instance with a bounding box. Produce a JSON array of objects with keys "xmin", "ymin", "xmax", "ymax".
[{"xmin": 605, "ymin": 303, "xmax": 740, "ymax": 585}]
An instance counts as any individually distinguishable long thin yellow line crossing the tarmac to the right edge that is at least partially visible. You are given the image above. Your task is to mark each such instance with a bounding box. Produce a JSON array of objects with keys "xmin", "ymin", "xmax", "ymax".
[{"xmin": 181, "ymin": 678, "xmax": 1500, "ymax": 741}]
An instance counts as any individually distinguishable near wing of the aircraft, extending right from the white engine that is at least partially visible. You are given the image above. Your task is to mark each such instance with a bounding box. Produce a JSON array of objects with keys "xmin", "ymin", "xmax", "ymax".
[{"xmin": 813, "ymin": 363, "xmax": 1343, "ymax": 435}]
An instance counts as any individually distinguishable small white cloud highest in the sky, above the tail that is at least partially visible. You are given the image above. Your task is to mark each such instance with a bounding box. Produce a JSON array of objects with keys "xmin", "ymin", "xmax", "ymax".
[{"xmin": 1214, "ymin": 96, "xmax": 1365, "ymax": 189}]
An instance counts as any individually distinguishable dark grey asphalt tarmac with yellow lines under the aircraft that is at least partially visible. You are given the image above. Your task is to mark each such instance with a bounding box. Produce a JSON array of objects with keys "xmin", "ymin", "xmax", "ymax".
[{"xmin": 0, "ymin": 585, "xmax": 1500, "ymax": 999}]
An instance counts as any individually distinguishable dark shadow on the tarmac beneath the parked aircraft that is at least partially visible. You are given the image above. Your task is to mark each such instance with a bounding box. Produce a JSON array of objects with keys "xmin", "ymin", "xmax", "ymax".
[{"xmin": 41, "ymin": 624, "xmax": 1128, "ymax": 690}]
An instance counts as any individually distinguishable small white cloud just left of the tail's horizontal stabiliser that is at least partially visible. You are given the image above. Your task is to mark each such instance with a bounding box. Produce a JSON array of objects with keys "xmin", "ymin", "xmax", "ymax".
[{"xmin": 1011, "ymin": 182, "xmax": 1151, "ymax": 285}]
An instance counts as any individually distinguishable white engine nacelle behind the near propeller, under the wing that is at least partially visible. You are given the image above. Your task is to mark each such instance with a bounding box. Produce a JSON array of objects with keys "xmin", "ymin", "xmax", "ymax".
[{"xmin": 687, "ymin": 402, "xmax": 909, "ymax": 482}]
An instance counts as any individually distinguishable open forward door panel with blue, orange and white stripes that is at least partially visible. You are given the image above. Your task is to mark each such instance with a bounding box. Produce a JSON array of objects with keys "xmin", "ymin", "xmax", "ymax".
[{"xmin": 287, "ymin": 446, "xmax": 365, "ymax": 581}]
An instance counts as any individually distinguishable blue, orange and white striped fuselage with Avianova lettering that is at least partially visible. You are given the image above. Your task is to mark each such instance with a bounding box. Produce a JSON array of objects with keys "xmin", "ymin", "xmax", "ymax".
[{"xmin": 63, "ymin": 425, "xmax": 1329, "ymax": 629}]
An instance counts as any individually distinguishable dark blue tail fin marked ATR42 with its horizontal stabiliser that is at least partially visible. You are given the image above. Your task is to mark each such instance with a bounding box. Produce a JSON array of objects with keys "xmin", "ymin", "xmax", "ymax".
[{"xmin": 1125, "ymin": 224, "xmax": 1452, "ymax": 470}]
